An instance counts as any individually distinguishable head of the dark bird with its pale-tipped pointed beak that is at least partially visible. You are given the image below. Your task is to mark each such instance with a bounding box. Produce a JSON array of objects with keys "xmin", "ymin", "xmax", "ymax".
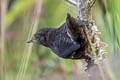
[{"xmin": 26, "ymin": 28, "xmax": 48, "ymax": 46}]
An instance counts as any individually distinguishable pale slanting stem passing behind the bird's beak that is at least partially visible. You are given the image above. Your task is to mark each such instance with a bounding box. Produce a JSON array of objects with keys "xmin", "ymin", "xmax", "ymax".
[{"xmin": 17, "ymin": 0, "xmax": 42, "ymax": 80}]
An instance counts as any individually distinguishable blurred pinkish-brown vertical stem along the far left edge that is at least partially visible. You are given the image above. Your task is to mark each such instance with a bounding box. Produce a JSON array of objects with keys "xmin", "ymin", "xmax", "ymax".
[{"xmin": 0, "ymin": 0, "xmax": 6, "ymax": 80}]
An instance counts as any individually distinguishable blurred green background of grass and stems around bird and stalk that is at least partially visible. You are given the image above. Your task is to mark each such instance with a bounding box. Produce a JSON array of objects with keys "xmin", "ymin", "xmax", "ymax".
[{"xmin": 0, "ymin": 0, "xmax": 120, "ymax": 80}]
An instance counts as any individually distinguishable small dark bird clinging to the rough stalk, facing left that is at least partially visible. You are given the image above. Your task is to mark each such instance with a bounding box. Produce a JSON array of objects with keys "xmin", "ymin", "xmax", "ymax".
[{"xmin": 27, "ymin": 13, "xmax": 89, "ymax": 59}]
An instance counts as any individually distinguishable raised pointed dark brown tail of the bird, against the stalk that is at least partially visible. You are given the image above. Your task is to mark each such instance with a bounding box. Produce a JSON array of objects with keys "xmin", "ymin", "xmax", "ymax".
[{"xmin": 66, "ymin": 13, "xmax": 86, "ymax": 40}]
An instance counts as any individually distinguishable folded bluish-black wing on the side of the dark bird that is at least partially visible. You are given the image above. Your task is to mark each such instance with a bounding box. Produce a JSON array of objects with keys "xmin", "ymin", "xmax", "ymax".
[{"xmin": 52, "ymin": 33, "xmax": 80, "ymax": 58}]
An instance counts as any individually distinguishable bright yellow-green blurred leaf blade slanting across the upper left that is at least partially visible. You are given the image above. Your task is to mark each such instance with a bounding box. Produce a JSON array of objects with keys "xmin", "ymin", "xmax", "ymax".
[{"xmin": 6, "ymin": 0, "xmax": 35, "ymax": 26}]
